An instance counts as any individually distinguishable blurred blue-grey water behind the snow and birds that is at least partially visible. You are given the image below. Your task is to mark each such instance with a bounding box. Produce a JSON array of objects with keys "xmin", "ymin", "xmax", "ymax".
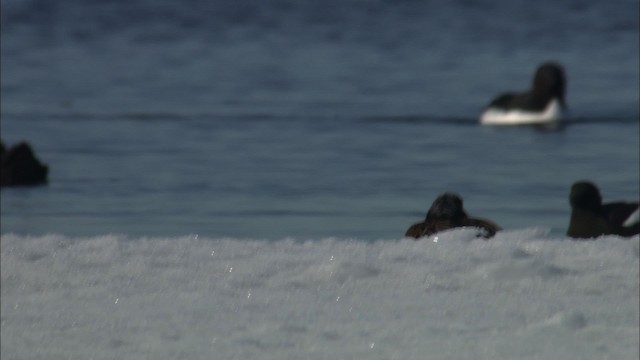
[{"xmin": 0, "ymin": 0, "xmax": 640, "ymax": 239}]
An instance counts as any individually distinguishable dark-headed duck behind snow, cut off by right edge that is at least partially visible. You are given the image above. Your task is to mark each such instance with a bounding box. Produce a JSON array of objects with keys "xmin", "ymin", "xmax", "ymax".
[{"xmin": 567, "ymin": 181, "xmax": 640, "ymax": 239}]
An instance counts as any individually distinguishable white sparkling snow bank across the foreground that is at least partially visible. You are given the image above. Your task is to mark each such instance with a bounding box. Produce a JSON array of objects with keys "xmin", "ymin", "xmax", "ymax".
[{"xmin": 1, "ymin": 228, "xmax": 639, "ymax": 360}]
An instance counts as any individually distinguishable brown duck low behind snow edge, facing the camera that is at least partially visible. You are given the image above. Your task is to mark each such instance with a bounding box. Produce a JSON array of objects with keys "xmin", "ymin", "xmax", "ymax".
[{"xmin": 404, "ymin": 193, "xmax": 502, "ymax": 239}]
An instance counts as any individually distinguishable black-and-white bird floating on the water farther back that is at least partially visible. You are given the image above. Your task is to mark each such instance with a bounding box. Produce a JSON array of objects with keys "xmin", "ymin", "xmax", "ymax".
[{"xmin": 480, "ymin": 62, "xmax": 566, "ymax": 125}]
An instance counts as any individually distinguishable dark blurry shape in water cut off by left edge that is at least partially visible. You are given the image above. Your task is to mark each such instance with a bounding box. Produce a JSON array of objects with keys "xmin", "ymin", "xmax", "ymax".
[{"xmin": 0, "ymin": 142, "xmax": 49, "ymax": 187}]
